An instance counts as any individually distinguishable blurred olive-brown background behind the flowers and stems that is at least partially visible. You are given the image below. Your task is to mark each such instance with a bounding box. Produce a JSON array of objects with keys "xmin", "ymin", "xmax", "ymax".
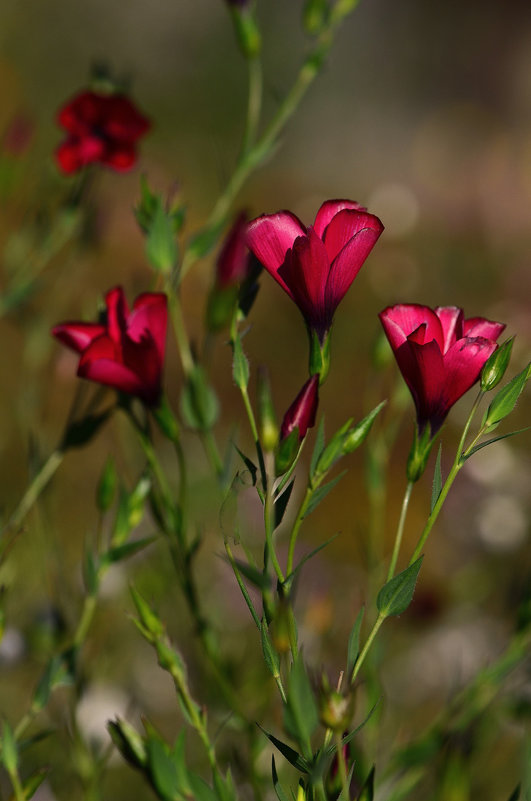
[{"xmin": 0, "ymin": 0, "xmax": 531, "ymax": 801}]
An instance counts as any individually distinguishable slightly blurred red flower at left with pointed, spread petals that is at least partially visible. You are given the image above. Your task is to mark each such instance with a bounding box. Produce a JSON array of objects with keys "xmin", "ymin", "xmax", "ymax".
[{"xmin": 52, "ymin": 287, "xmax": 167, "ymax": 406}]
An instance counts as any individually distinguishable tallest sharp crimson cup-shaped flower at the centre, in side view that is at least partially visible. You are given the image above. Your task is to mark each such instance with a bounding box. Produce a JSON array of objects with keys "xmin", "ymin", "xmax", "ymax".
[{"xmin": 247, "ymin": 200, "xmax": 383, "ymax": 343}]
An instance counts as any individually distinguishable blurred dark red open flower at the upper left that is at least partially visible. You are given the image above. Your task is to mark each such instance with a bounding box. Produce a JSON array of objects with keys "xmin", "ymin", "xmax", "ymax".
[{"xmin": 55, "ymin": 91, "xmax": 150, "ymax": 174}]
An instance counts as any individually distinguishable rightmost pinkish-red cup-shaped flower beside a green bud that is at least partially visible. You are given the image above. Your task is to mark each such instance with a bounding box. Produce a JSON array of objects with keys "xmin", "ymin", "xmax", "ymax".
[{"xmin": 379, "ymin": 303, "xmax": 505, "ymax": 436}]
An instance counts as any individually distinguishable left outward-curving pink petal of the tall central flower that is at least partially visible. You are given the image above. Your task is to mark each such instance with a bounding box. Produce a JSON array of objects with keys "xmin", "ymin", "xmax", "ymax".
[{"xmin": 247, "ymin": 211, "xmax": 306, "ymax": 295}]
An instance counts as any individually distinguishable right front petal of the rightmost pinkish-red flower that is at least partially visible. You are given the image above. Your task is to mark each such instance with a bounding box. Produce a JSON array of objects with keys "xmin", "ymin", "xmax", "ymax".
[{"xmin": 444, "ymin": 337, "xmax": 497, "ymax": 408}]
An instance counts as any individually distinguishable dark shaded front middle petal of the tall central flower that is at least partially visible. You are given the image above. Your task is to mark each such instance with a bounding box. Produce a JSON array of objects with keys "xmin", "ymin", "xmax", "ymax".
[{"xmin": 278, "ymin": 228, "xmax": 334, "ymax": 334}]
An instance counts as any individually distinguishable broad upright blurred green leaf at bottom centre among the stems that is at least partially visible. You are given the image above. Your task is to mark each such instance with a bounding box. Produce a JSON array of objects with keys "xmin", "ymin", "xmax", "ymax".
[{"xmin": 284, "ymin": 656, "xmax": 319, "ymax": 759}]
